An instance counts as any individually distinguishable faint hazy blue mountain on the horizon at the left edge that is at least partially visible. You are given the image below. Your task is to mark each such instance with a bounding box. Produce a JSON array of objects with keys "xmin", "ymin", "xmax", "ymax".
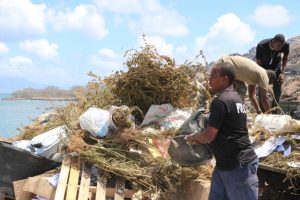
[{"xmin": 0, "ymin": 76, "xmax": 46, "ymax": 93}]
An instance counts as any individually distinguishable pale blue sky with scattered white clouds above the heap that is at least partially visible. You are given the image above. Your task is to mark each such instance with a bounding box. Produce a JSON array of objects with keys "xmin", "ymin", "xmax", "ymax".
[{"xmin": 0, "ymin": 0, "xmax": 300, "ymax": 88}]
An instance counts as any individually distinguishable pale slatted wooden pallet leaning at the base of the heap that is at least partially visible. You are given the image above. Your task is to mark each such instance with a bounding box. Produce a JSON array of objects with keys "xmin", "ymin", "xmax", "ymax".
[{"xmin": 54, "ymin": 156, "xmax": 158, "ymax": 200}]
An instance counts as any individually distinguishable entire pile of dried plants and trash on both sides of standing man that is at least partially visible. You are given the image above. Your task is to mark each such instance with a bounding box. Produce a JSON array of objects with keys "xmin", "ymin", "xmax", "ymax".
[{"xmin": 2, "ymin": 45, "xmax": 300, "ymax": 199}]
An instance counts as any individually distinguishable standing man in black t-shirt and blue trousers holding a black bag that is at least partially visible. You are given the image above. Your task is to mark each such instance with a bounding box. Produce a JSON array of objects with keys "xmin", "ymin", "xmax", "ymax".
[{"xmin": 186, "ymin": 62, "xmax": 258, "ymax": 200}]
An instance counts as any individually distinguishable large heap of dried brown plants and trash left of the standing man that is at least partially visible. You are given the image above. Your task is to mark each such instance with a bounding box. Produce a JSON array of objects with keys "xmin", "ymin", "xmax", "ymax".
[{"xmin": 17, "ymin": 45, "xmax": 212, "ymax": 199}]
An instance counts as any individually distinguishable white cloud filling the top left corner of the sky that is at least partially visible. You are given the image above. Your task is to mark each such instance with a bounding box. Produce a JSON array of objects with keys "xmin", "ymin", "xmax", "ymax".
[{"xmin": 0, "ymin": 0, "xmax": 46, "ymax": 40}]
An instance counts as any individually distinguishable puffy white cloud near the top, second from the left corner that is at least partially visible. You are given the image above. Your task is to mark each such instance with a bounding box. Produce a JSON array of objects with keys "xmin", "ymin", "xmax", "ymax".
[{"xmin": 49, "ymin": 5, "xmax": 108, "ymax": 39}]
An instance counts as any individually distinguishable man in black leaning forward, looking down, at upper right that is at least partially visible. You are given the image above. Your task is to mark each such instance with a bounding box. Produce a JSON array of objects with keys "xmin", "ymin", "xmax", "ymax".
[{"xmin": 255, "ymin": 34, "xmax": 290, "ymax": 110}]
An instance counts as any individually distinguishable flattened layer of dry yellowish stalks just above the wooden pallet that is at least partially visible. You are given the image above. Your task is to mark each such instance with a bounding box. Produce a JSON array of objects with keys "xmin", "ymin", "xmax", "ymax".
[{"xmin": 70, "ymin": 129, "xmax": 211, "ymax": 194}]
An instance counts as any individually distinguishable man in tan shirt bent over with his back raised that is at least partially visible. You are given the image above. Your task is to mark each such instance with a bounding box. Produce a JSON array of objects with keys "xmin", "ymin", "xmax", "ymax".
[{"xmin": 218, "ymin": 56, "xmax": 275, "ymax": 113}]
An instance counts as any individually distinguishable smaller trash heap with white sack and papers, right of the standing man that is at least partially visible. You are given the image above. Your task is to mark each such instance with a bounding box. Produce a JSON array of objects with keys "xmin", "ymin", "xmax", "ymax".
[{"xmin": 249, "ymin": 114, "xmax": 300, "ymax": 194}]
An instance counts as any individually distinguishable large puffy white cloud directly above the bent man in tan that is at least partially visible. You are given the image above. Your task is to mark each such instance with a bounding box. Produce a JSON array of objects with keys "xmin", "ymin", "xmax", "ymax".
[{"xmin": 196, "ymin": 13, "xmax": 255, "ymax": 61}]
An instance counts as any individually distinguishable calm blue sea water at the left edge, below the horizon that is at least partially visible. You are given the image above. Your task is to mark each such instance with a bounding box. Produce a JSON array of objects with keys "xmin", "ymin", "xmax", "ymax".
[{"xmin": 0, "ymin": 93, "xmax": 67, "ymax": 138}]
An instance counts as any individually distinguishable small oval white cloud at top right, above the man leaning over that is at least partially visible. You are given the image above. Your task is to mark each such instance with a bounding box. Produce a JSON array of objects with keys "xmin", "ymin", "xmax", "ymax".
[{"xmin": 250, "ymin": 4, "xmax": 293, "ymax": 27}]
